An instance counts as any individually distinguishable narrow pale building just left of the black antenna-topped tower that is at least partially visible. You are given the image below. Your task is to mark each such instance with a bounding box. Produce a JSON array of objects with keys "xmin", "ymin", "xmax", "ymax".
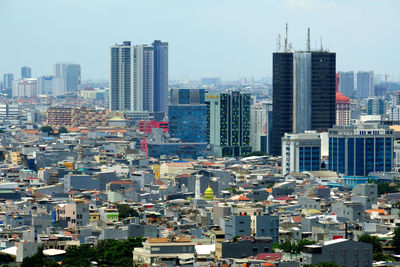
[{"xmin": 250, "ymin": 103, "xmax": 272, "ymax": 154}]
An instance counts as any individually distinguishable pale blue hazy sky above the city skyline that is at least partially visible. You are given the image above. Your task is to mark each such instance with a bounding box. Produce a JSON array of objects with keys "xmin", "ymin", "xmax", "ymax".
[{"xmin": 0, "ymin": 0, "xmax": 400, "ymax": 80}]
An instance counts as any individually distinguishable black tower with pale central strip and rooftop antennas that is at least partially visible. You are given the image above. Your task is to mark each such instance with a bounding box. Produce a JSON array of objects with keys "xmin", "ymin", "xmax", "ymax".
[{"xmin": 271, "ymin": 51, "xmax": 336, "ymax": 155}]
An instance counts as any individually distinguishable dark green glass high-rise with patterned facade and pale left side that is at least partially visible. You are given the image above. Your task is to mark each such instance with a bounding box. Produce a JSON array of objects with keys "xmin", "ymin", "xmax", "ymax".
[{"xmin": 205, "ymin": 91, "xmax": 251, "ymax": 157}]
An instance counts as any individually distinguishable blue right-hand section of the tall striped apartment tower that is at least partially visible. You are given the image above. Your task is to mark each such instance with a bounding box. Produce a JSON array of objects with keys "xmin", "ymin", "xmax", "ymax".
[{"xmin": 153, "ymin": 40, "xmax": 168, "ymax": 118}]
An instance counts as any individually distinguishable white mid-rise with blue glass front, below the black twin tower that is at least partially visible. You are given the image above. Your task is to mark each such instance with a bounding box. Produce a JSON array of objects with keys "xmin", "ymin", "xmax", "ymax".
[{"xmin": 282, "ymin": 131, "xmax": 321, "ymax": 175}]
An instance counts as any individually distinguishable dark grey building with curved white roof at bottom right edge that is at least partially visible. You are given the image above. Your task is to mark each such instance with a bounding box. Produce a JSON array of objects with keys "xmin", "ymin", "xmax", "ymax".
[{"xmin": 300, "ymin": 239, "xmax": 373, "ymax": 267}]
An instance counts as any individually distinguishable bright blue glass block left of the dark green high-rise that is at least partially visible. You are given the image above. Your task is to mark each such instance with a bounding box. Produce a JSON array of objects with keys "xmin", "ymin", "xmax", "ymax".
[{"xmin": 168, "ymin": 89, "xmax": 207, "ymax": 143}]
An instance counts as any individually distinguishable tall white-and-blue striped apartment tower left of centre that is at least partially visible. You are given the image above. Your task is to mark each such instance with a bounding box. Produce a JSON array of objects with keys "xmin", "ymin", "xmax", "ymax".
[{"xmin": 110, "ymin": 41, "xmax": 168, "ymax": 119}]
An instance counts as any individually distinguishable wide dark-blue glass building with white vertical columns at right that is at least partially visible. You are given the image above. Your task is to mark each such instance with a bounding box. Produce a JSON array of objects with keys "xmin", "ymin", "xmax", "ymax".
[{"xmin": 328, "ymin": 124, "xmax": 394, "ymax": 176}]
